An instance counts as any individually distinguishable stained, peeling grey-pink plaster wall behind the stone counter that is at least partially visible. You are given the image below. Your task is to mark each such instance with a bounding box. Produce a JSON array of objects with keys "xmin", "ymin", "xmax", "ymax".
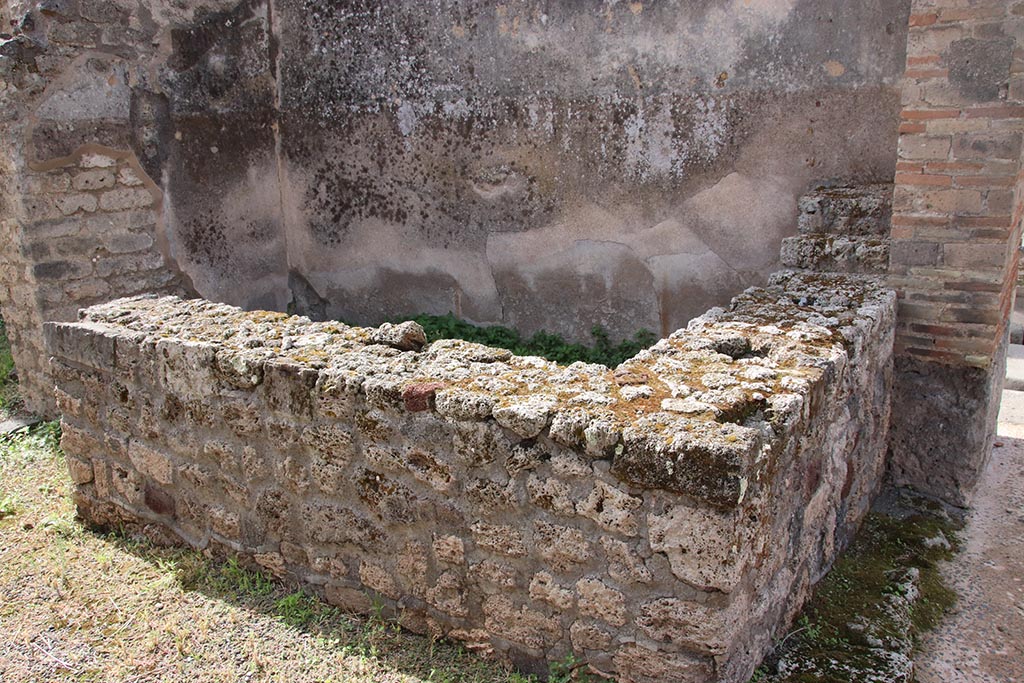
[{"xmin": 0, "ymin": 0, "xmax": 909, "ymax": 350}]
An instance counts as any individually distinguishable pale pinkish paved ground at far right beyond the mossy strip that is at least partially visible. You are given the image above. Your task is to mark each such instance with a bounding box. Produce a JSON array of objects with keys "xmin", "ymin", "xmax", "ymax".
[{"xmin": 914, "ymin": 390, "xmax": 1024, "ymax": 683}]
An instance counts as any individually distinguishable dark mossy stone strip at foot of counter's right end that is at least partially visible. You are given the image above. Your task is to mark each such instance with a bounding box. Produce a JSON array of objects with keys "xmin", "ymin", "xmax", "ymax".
[{"xmin": 752, "ymin": 496, "xmax": 961, "ymax": 683}]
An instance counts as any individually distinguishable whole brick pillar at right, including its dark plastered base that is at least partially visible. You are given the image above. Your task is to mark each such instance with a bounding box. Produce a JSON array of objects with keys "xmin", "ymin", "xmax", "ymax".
[{"xmin": 890, "ymin": 0, "xmax": 1024, "ymax": 505}]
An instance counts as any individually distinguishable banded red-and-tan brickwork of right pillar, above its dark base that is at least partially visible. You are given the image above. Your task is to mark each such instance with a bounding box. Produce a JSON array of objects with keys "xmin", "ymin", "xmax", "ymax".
[{"xmin": 890, "ymin": 0, "xmax": 1024, "ymax": 368}]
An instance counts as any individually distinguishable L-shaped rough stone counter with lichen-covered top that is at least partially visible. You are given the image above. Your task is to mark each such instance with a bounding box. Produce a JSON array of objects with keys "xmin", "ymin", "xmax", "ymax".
[{"xmin": 46, "ymin": 273, "xmax": 895, "ymax": 683}]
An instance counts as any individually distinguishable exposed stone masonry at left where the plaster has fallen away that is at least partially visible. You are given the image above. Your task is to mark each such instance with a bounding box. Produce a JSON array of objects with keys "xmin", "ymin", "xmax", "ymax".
[{"xmin": 0, "ymin": 145, "xmax": 187, "ymax": 415}]
